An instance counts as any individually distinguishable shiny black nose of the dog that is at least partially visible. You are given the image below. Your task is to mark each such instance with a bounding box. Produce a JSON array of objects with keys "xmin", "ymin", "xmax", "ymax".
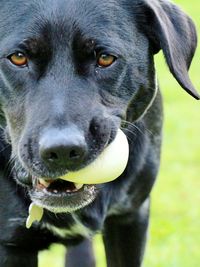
[{"xmin": 39, "ymin": 127, "xmax": 87, "ymax": 168}]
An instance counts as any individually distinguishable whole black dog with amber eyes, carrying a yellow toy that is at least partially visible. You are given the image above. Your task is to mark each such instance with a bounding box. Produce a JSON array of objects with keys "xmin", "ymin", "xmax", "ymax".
[{"xmin": 0, "ymin": 0, "xmax": 199, "ymax": 267}]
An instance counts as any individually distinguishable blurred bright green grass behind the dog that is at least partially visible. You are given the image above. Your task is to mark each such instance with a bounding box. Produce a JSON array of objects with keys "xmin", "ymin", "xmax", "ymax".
[{"xmin": 39, "ymin": 0, "xmax": 200, "ymax": 267}]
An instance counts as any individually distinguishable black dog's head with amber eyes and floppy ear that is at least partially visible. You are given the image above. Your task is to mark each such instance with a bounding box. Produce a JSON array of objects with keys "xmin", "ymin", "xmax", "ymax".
[{"xmin": 0, "ymin": 0, "xmax": 199, "ymax": 214}]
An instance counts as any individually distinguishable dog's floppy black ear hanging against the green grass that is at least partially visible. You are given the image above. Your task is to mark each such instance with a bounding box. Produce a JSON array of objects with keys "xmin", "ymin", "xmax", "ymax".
[{"xmin": 140, "ymin": 0, "xmax": 200, "ymax": 99}]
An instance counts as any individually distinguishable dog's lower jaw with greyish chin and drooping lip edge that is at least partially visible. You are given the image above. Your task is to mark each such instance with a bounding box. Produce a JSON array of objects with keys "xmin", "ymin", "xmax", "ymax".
[{"xmin": 13, "ymin": 161, "xmax": 98, "ymax": 213}]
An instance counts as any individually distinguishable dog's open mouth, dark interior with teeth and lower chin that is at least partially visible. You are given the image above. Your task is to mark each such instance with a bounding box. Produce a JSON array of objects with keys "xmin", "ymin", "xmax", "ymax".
[{"xmin": 30, "ymin": 177, "xmax": 97, "ymax": 213}]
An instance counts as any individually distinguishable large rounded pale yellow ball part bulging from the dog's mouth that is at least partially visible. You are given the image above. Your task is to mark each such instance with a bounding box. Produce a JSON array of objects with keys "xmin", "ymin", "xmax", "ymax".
[{"xmin": 60, "ymin": 129, "xmax": 129, "ymax": 184}]
